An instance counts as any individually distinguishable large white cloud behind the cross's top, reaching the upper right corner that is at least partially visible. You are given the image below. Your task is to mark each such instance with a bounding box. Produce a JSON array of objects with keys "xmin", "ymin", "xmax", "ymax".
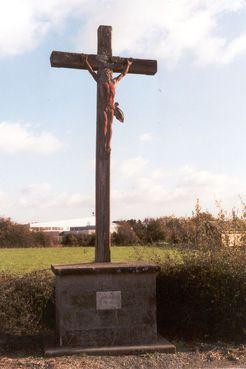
[{"xmin": 78, "ymin": 0, "xmax": 246, "ymax": 65}]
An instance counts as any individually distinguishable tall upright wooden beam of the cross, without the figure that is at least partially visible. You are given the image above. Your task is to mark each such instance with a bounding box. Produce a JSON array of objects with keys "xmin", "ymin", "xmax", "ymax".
[{"xmin": 95, "ymin": 26, "xmax": 112, "ymax": 262}]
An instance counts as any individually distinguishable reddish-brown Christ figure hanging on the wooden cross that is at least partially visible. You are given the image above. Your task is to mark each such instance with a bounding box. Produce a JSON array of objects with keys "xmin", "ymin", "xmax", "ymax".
[{"xmin": 85, "ymin": 57, "xmax": 132, "ymax": 153}]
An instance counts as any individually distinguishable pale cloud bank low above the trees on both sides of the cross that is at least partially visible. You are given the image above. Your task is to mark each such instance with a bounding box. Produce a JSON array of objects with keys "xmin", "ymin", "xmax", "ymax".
[{"xmin": 0, "ymin": 162, "xmax": 246, "ymax": 221}]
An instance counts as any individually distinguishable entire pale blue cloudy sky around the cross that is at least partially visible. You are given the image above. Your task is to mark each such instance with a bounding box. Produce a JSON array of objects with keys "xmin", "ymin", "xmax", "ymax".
[{"xmin": 0, "ymin": 0, "xmax": 246, "ymax": 222}]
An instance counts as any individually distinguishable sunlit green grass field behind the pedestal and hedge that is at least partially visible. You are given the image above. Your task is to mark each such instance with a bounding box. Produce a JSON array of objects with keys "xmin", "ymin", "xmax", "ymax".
[{"xmin": 0, "ymin": 246, "xmax": 182, "ymax": 274}]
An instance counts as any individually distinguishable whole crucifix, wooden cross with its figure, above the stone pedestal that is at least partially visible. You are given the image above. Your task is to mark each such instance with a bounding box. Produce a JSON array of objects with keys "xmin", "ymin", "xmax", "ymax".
[{"xmin": 50, "ymin": 26, "xmax": 157, "ymax": 262}]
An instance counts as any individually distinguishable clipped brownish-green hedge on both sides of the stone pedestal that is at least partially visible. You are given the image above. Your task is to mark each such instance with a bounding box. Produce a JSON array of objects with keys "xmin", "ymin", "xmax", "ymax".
[{"xmin": 0, "ymin": 251, "xmax": 246, "ymax": 342}]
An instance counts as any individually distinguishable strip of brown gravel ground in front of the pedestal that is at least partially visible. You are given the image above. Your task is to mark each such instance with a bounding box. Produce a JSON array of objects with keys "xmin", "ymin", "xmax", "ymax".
[{"xmin": 0, "ymin": 337, "xmax": 246, "ymax": 369}]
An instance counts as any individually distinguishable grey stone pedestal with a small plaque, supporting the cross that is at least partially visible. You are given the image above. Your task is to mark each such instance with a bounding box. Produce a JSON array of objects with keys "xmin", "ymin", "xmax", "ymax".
[{"xmin": 46, "ymin": 263, "xmax": 175, "ymax": 354}]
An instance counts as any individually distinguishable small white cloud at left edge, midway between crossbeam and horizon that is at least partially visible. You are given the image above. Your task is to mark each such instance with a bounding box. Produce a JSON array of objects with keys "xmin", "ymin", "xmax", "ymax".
[{"xmin": 0, "ymin": 122, "xmax": 62, "ymax": 155}]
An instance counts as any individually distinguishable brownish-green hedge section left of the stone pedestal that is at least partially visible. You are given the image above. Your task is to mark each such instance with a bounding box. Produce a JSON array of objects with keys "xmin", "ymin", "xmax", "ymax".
[{"xmin": 0, "ymin": 271, "xmax": 54, "ymax": 335}]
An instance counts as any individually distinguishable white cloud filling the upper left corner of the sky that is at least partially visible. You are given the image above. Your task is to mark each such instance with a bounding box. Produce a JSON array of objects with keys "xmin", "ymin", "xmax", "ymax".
[{"xmin": 0, "ymin": 0, "xmax": 85, "ymax": 56}]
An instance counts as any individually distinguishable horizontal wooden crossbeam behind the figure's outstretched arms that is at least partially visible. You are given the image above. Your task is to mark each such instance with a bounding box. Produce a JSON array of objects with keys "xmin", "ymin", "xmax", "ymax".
[{"xmin": 50, "ymin": 51, "xmax": 157, "ymax": 75}]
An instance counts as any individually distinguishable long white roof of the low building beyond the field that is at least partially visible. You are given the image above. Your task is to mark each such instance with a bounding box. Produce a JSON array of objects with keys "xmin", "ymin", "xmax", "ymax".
[{"xmin": 30, "ymin": 217, "xmax": 96, "ymax": 231}]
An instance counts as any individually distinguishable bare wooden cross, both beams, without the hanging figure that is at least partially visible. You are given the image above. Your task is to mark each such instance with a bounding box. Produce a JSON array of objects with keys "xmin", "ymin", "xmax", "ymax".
[{"xmin": 50, "ymin": 26, "xmax": 157, "ymax": 262}]
